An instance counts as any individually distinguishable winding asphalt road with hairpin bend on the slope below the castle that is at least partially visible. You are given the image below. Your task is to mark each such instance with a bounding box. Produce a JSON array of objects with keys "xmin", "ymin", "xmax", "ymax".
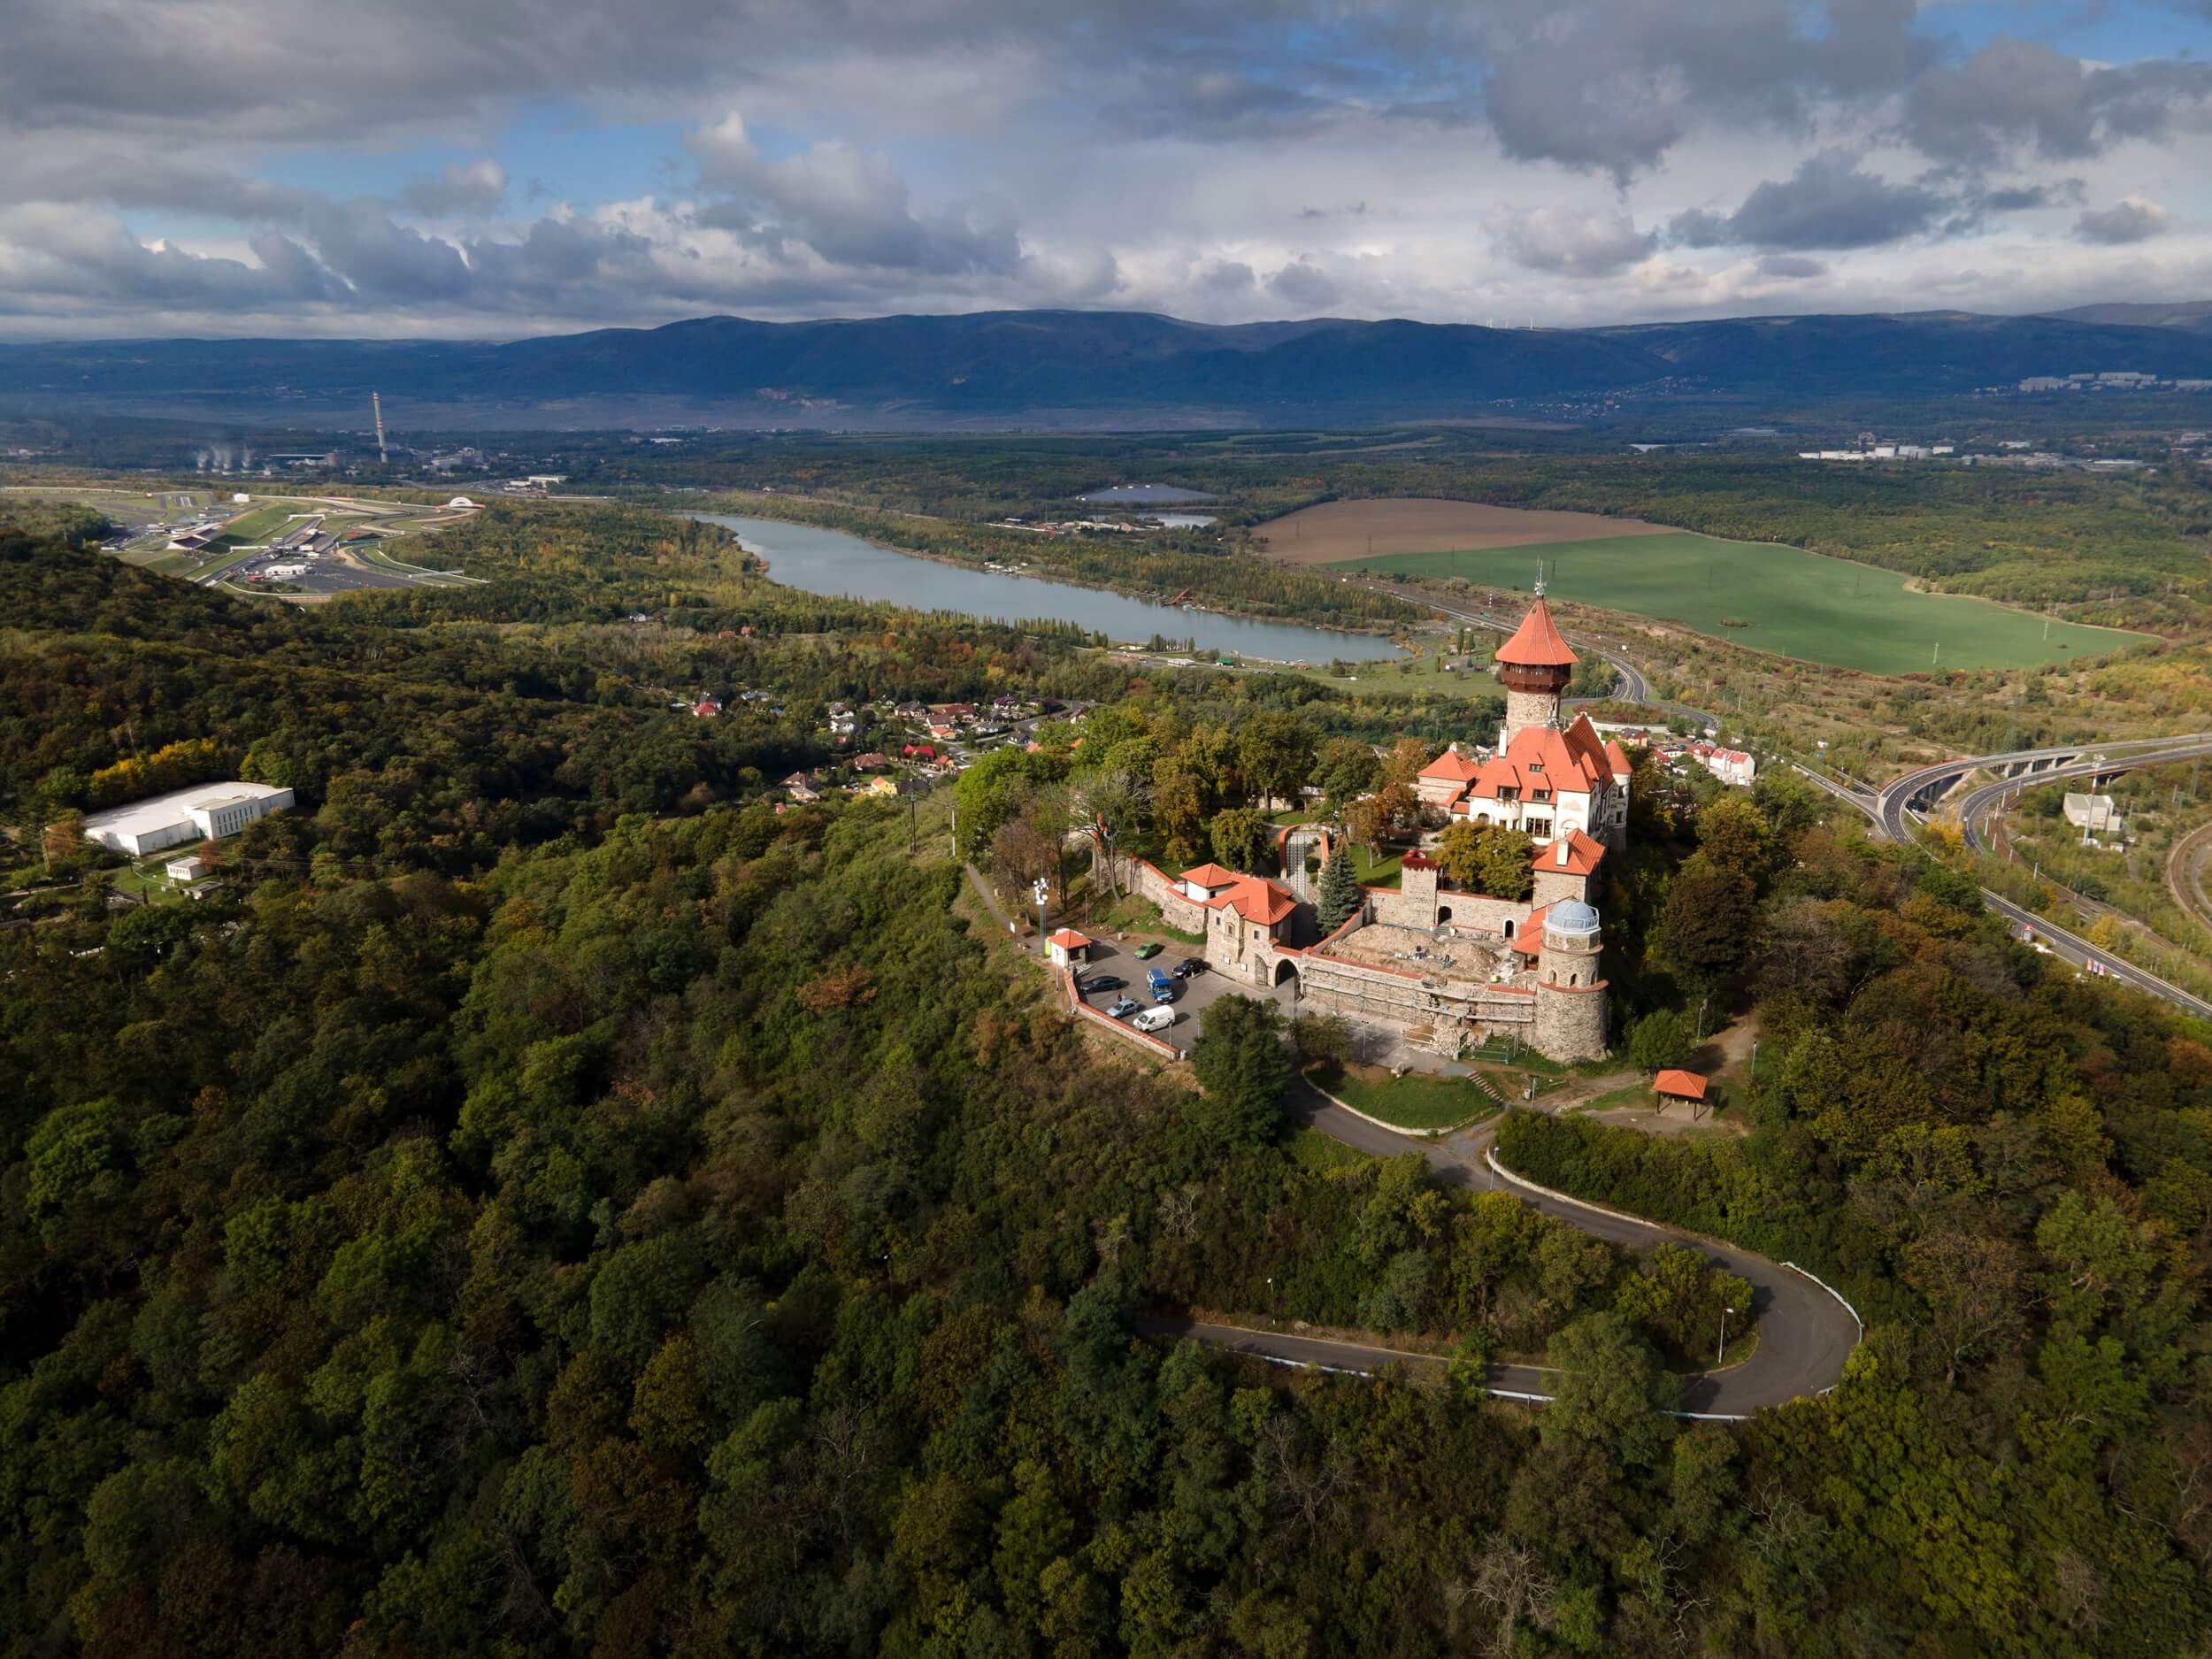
[{"xmin": 1140, "ymin": 1079, "xmax": 1858, "ymax": 1418}]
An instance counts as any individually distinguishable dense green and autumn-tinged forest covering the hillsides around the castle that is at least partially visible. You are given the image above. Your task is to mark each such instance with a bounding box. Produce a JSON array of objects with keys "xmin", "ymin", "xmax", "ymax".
[{"xmin": 0, "ymin": 509, "xmax": 2212, "ymax": 1659}]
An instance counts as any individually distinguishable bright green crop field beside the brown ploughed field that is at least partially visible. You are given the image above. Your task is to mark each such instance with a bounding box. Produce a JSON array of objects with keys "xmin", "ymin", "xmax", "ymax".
[{"xmin": 1330, "ymin": 531, "xmax": 2148, "ymax": 675}]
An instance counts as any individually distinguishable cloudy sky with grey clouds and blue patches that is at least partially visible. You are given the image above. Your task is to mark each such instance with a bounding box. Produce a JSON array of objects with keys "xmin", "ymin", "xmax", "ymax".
[{"xmin": 0, "ymin": 0, "xmax": 2212, "ymax": 339}]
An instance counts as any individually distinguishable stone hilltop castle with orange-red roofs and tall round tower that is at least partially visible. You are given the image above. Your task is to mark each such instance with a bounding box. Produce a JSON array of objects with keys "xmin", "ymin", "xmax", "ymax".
[{"xmin": 1128, "ymin": 593, "xmax": 1628, "ymax": 1062}]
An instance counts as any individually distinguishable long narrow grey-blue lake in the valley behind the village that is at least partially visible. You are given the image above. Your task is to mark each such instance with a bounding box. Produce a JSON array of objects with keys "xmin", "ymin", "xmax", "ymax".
[{"xmin": 693, "ymin": 513, "xmax": 1401, "ymax": 664}]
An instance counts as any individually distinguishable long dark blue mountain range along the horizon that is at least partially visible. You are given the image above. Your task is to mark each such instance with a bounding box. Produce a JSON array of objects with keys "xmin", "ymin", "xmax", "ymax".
[{"xmin": 0, "ymin": 303, "xmax": 2212, "ymax": 427}]
